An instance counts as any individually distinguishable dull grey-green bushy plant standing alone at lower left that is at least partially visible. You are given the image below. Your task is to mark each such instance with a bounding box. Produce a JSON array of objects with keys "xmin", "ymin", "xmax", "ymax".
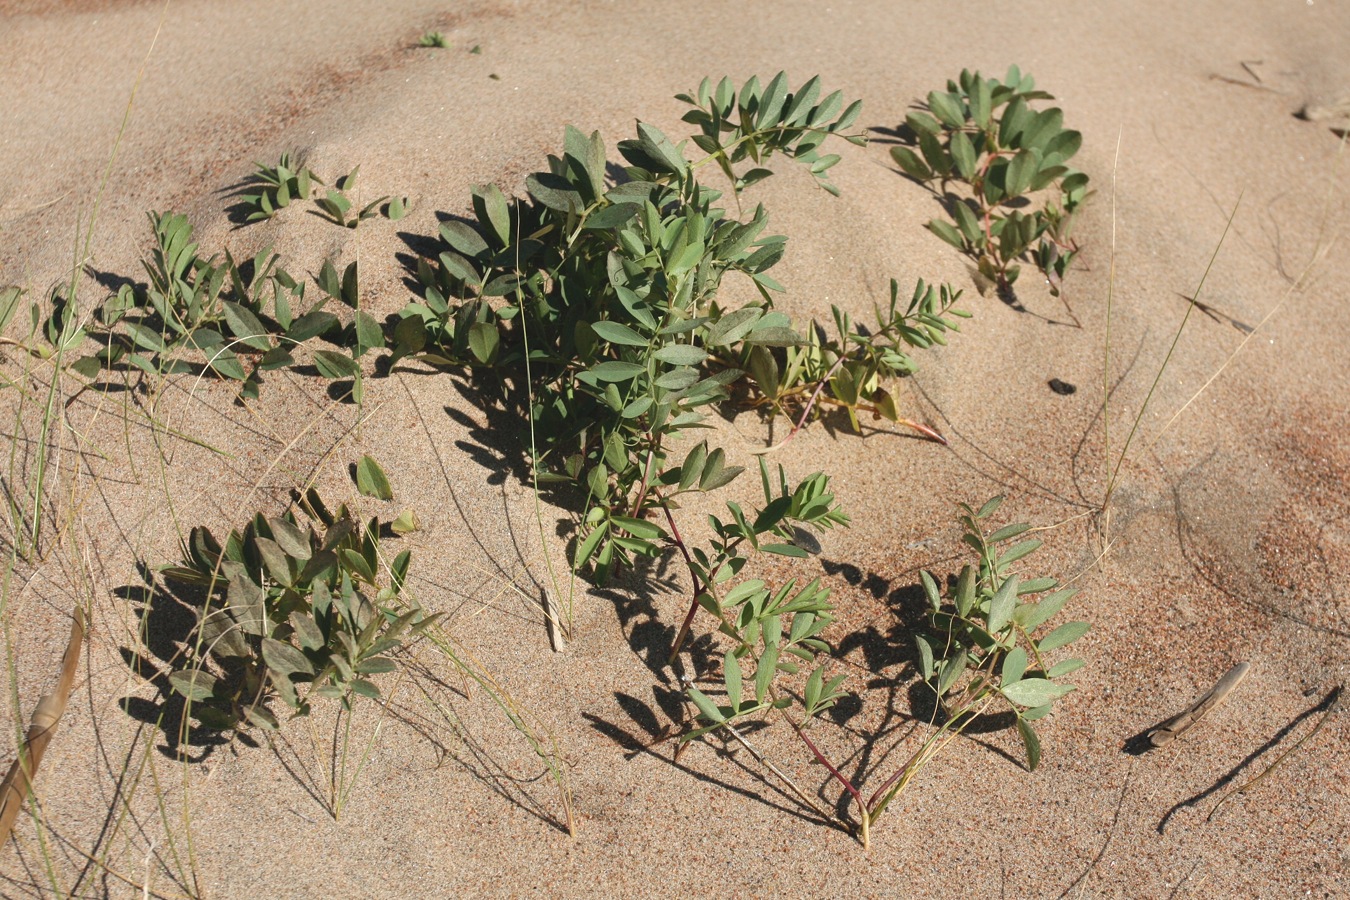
[{"xmin": 162, "ymin": 490, "xmax": 437, "ymax": 729}]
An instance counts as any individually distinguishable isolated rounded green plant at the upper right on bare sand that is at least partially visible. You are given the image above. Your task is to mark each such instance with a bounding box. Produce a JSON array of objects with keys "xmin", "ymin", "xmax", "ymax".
[{"xmin": 891, "ymin": 66, "xmax": 1089, "ymax": 296}]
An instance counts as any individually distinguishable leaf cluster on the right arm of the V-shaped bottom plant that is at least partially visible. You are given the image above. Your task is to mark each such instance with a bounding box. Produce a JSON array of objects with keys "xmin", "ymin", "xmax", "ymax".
[{"xmin": 915, "ymin": 497, "xmax": 1089, "ymax": 769}]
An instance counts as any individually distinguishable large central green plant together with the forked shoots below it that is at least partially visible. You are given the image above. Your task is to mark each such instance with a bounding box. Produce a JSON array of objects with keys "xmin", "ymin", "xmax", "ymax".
[{"xmin": 392, "ymin": 73, "xmax": 1085, "ymax": 845}]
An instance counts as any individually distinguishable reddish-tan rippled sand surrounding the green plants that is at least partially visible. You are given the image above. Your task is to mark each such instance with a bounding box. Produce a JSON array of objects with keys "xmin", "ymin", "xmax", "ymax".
[{"xmin": 0, "ymin": 0, "xmax": 1350, "ymax": 897}]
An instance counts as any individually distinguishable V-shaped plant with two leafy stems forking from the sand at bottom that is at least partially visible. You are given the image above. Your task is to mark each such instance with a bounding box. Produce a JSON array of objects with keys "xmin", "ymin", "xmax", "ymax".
[{"xmin": 680, "ymin": 496, "xmax": 1088, "ymax": 846}]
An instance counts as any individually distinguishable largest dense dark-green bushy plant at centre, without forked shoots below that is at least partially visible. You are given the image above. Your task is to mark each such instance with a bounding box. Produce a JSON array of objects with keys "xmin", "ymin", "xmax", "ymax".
[{"xmin": 394, "ymin": 74, "xmax": 957, "ymax": 579}]
